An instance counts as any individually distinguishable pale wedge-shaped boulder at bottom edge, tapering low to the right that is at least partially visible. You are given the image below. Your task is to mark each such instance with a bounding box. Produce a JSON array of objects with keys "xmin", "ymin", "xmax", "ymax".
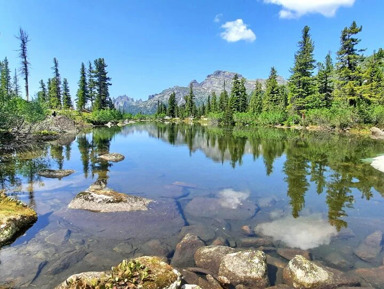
[{"xmin": 283, "ymin": 255, "xmax": 360, "ymax": 289}]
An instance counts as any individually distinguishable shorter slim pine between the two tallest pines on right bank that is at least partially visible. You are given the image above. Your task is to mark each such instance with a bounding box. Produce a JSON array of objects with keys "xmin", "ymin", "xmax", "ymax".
[{"xmin": 317, "ymin": 53, "xmax": 334, "ymax": 108}]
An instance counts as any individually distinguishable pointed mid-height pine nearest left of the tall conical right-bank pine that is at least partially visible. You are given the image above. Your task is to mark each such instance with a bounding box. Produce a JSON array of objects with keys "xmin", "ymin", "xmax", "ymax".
[{"xmin": 263, "ymin": 67, "xmax": 281, "ymax": 111}]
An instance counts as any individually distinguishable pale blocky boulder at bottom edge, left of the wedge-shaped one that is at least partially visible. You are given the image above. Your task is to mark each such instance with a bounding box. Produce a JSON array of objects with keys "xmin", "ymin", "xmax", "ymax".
[{"xmin": 219, "ymin": 250, "xmax": 269, "ymax": 289}]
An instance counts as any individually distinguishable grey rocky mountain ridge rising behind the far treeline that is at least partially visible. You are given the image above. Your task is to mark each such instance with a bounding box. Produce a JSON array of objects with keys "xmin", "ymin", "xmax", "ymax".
[{"xmin": 114, "ymin": 70, "xmax": 286, "ymax": 114}]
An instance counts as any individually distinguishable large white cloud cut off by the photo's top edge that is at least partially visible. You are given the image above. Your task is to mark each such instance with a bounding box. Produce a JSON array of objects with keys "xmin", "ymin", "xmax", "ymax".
[{"xmin": 264, "ymin": 0, "xmax": 355, "ymax": 18}]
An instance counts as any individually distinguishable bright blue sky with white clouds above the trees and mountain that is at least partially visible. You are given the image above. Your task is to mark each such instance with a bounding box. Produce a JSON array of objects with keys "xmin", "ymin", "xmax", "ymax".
[{"xmin": 0, "ymin": 0, "xmax": 384, "ymax": 99}]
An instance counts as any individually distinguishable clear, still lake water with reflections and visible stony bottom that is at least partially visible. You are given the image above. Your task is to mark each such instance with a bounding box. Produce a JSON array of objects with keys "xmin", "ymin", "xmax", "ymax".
[{"xmin": 0, "ymin": 124, "xmax": 384, "ymax": 288}]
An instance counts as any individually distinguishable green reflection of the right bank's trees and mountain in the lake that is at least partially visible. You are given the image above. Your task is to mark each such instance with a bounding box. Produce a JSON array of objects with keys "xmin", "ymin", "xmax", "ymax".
[{"xmin": 146, "ymin": 124, "xmax": 384, "ymax": 231}]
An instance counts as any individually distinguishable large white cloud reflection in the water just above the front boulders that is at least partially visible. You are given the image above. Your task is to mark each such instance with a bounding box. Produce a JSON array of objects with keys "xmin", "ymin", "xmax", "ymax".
[{"xmin": 255, "ymin": 214, "xmax": 337, "ymax": 250}]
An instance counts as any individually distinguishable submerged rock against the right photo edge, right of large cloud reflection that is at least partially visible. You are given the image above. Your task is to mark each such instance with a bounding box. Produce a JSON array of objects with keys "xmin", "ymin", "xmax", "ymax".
[{"xmin": 353, "ymin": 231, "xmax": 383, "ymax": 262}]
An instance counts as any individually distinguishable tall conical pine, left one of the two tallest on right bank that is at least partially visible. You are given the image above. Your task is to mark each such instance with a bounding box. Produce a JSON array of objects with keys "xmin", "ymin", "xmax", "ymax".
[{"xmin": 289, "ymin": 26, "xmax": 316, "ymax": 113}]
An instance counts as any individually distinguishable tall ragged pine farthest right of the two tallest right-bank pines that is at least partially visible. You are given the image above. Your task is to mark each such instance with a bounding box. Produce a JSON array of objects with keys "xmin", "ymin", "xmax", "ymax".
[{"xmin": 335, "ymin": 21, "xmax": 363, "ymax": 106}]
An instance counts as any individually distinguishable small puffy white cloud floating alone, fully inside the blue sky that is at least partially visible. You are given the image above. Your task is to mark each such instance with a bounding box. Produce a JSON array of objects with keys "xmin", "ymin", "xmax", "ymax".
[{"xmin": 220, "ymin": 19, "xmax": 256, "ymax": 42}]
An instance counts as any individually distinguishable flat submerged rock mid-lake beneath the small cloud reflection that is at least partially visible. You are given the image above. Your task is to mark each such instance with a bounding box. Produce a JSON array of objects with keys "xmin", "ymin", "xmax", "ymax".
[{"xmin": 185, "ymin": 197, "xmax": 258, "ymax": 220}]
